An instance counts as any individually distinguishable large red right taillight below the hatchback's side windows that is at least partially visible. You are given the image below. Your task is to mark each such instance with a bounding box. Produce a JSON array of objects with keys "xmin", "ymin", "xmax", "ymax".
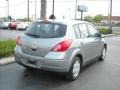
[{"xmin": 52, "ymin": 40, "xmax": 73, "ymax": 52}]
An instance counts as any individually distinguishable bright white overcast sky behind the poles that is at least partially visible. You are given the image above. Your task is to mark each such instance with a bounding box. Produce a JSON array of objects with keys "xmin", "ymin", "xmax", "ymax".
[{"xmin": 0, "ymin": 0, "xmax": 120, "ymax": 19}]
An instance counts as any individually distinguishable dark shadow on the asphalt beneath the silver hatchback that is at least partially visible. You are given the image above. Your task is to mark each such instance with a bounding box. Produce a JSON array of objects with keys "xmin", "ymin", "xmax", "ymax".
[{"xmin": 14, "ymin": 61, "xmax": 102, "ymax": 88}]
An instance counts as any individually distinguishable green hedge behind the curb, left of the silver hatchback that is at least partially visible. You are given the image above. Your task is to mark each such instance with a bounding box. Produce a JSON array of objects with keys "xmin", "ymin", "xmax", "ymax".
[{"xmin": 0, "ymin": 40, "xmax": 16, "ymax": 58}]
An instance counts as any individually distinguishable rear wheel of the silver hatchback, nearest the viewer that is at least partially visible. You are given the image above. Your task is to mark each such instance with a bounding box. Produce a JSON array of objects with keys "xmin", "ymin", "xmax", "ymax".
[{"xmin": 66, "ymin": 56, "xmax": 81, "ymax": 81}]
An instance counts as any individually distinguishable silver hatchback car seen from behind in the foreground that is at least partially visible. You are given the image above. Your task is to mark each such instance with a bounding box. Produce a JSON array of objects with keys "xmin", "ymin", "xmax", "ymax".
[{"xmin": 14, "ymin": 20, "xmax": 107, "ymax": 80}]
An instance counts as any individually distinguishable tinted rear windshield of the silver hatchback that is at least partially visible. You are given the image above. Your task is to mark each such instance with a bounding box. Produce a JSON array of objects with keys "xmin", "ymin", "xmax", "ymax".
[{"xmin": 25, "ymin": 22, "xmax": 67, "ymax": 38}]
